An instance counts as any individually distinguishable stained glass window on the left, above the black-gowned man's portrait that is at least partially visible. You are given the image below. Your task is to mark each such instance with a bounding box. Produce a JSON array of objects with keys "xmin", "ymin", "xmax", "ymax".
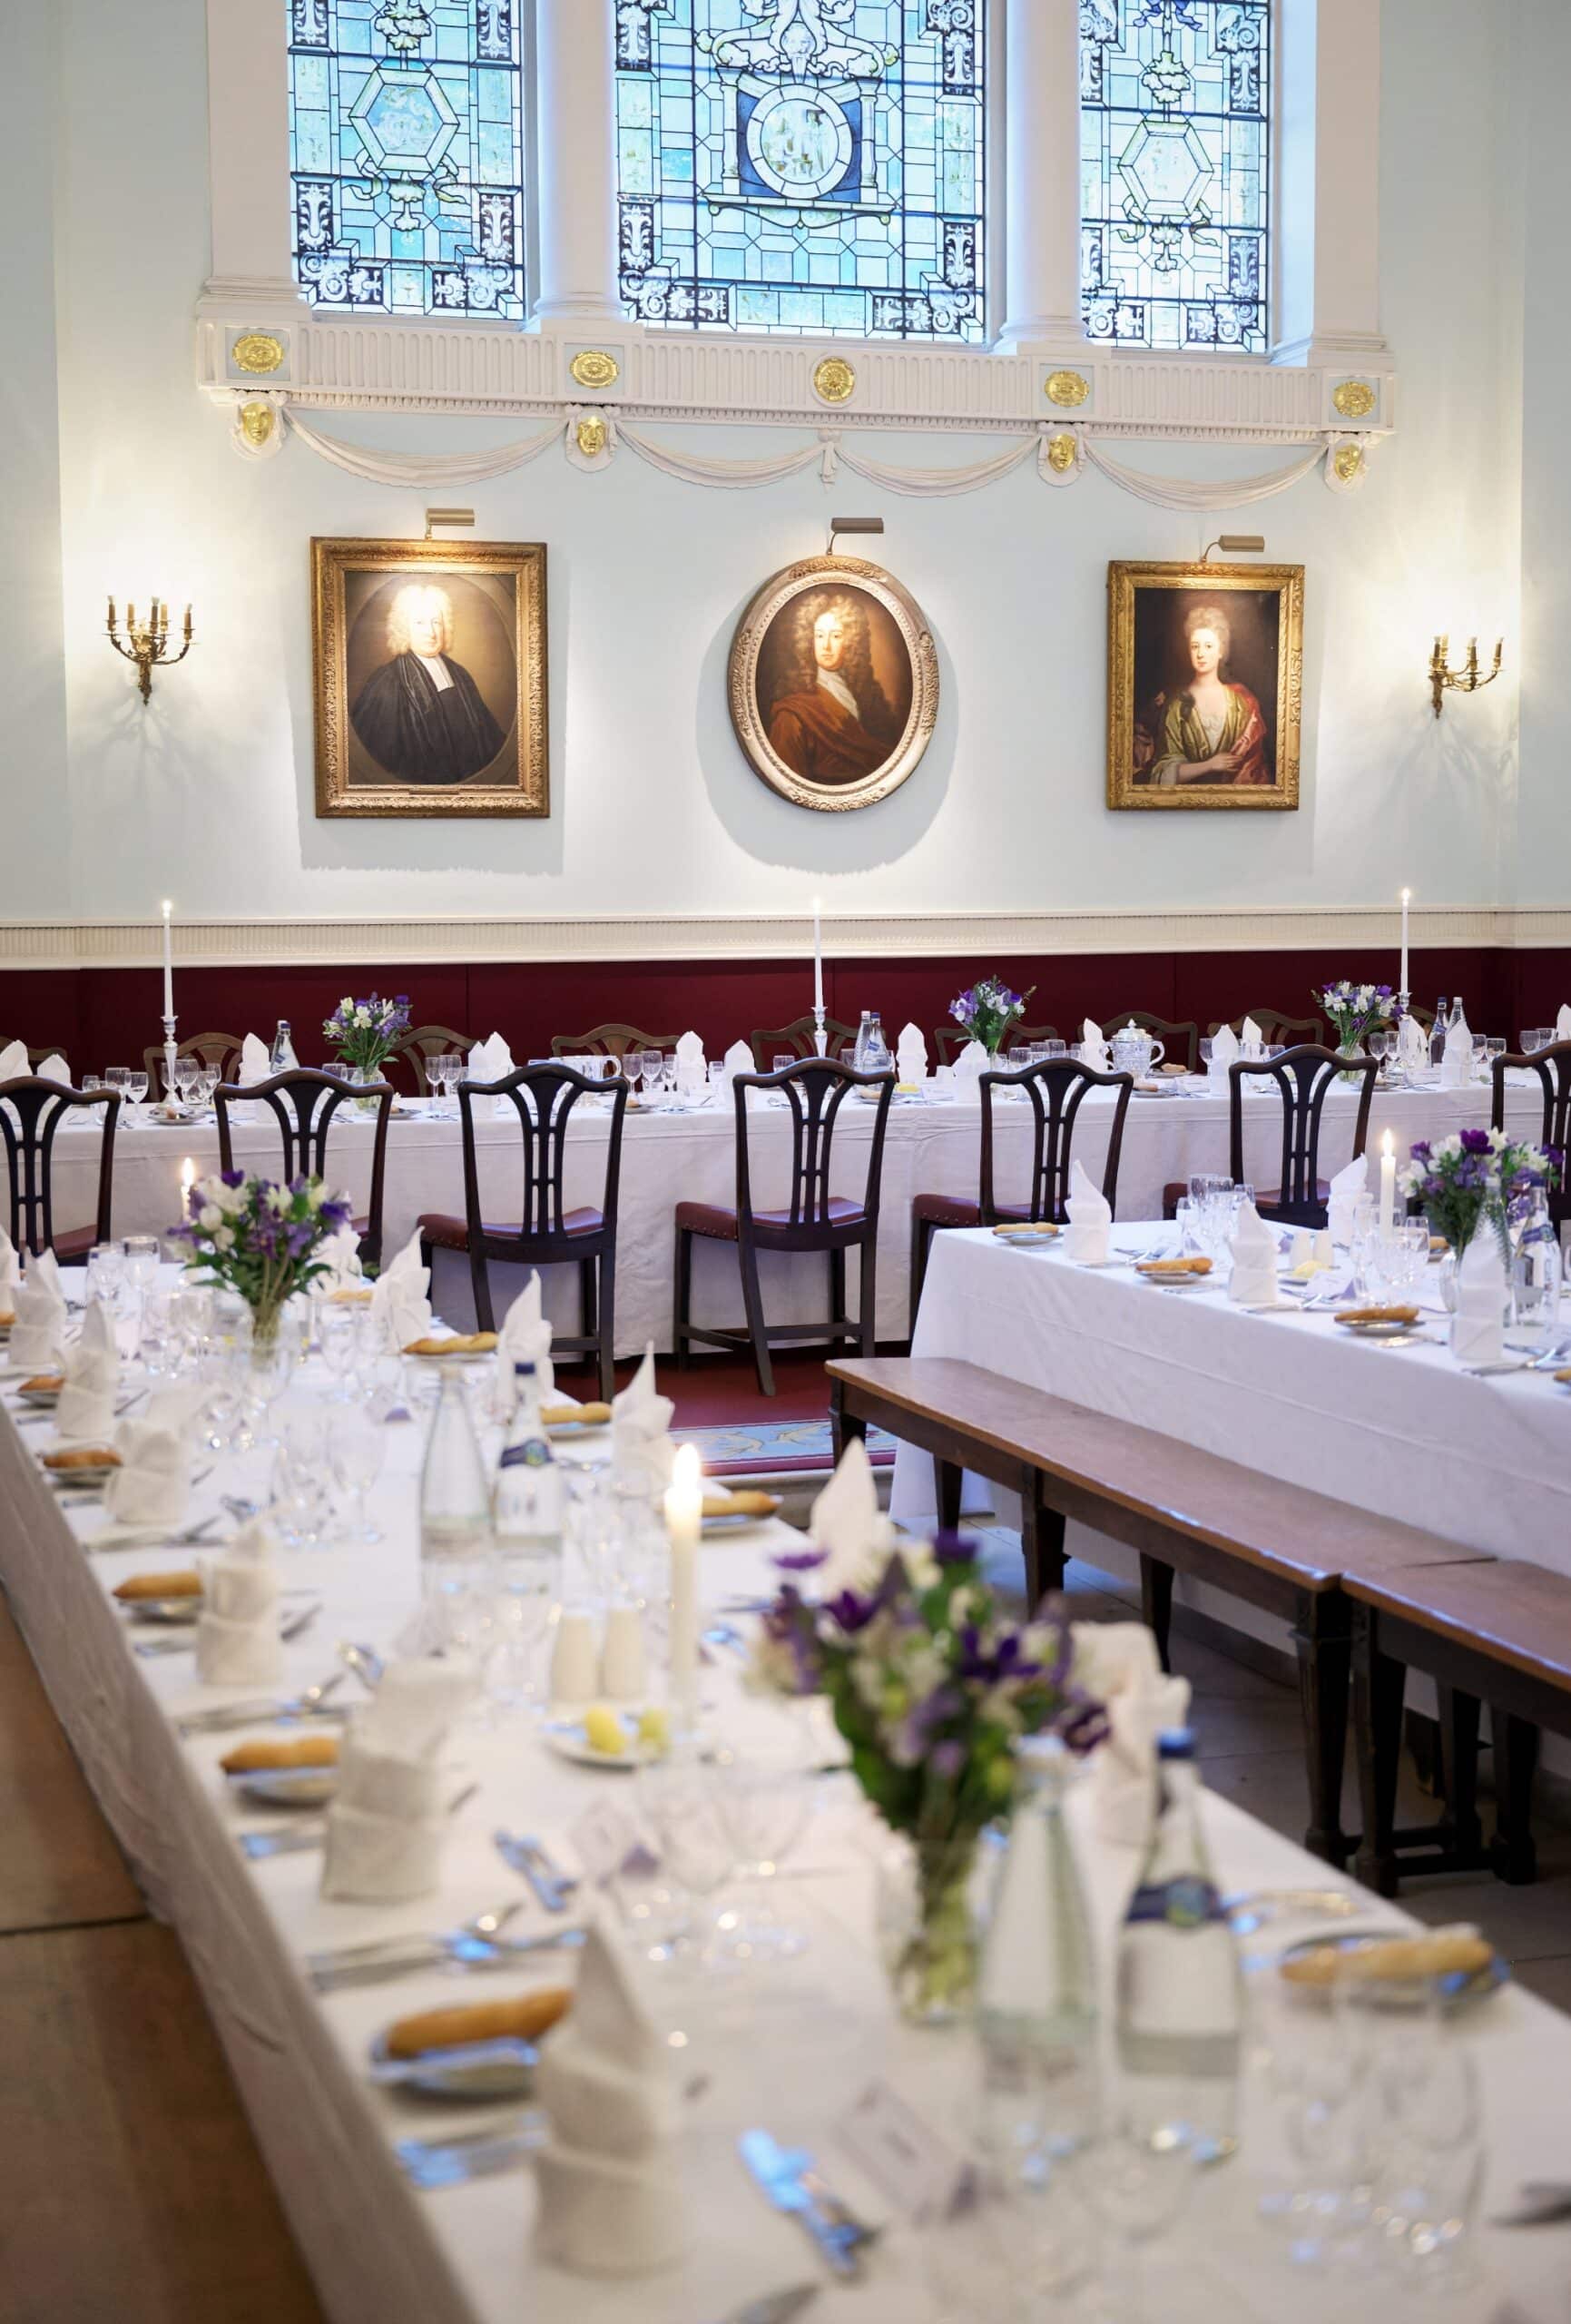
[{"xmin": 286, "ymin": 0, "xmax": 525, "ymax": 319}]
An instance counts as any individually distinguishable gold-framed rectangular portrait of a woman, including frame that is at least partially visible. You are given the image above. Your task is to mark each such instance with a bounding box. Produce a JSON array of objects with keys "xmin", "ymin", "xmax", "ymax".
[{"xmin": 1106, "ymin": 563, "xmax": 1304, "ymax": 811}]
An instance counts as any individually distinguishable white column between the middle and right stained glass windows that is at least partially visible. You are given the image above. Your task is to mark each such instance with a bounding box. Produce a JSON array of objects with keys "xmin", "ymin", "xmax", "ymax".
[{"xmin": 999, "ymin": 0, "xmax": 1085, "ymax": 353}]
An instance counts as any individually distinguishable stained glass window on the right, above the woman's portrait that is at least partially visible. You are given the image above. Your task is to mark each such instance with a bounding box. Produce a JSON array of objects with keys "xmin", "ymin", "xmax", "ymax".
[{"xmin": 1081, "ymin": 0, "xmax": 1272, "ymax": 356}]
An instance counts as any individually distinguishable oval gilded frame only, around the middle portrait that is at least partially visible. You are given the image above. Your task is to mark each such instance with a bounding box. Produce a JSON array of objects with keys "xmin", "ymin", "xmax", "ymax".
[{"xmin": 727, "ymin": 557, "xmax": 939, "ymax": 813}]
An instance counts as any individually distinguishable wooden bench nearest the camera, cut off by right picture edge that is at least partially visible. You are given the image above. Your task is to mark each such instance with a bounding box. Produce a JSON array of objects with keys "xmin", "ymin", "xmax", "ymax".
[{"xmin": 1343, "ymin": 1557, "xmax": 1571, "ymax": 1896}]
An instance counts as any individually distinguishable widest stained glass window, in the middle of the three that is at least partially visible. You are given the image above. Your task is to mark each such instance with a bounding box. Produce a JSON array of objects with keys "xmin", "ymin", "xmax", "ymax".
[{"xmin": 616, "ymin": 0, "xmax": 987, "ymax": 344}]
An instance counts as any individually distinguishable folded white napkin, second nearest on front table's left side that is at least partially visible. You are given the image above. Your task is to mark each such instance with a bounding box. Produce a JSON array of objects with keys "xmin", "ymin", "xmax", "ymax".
[{"xmin": 320, "ymin": 1655, "xmax": 478, "ymax": 1904}]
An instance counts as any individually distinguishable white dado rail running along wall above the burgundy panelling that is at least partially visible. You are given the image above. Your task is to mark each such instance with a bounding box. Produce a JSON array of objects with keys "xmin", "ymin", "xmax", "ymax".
[{"xmin": 0, "ymin": 901, "xmax": 1571, "ymax": 971}]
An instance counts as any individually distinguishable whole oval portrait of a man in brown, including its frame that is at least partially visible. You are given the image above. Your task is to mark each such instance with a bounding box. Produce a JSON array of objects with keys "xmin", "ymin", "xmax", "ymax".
[{"xmin": 727, "ymin": 557, "xmax": 939, "ymax": 813}]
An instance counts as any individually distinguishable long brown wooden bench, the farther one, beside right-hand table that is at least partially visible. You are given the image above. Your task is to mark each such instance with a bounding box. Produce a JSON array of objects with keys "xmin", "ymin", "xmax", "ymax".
[{"xmin": 825, "ymin": 1354, "xmax": 1494, "ymax": 1864}]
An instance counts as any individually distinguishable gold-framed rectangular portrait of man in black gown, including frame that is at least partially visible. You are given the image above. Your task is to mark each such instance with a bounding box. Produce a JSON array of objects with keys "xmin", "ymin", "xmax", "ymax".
[{"xmin": 311, "ymin": 539, "xmax": 551, "ymax": 818}]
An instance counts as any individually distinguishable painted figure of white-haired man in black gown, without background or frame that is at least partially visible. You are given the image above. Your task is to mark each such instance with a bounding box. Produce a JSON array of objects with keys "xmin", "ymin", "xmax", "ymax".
[{"xmin": 349, "ymin": 581, "xmax": 505, "ymax": 783}]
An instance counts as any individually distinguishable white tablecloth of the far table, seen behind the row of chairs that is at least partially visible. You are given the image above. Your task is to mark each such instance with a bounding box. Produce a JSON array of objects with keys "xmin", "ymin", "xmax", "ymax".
[{"xmin": 39, "ymin": 1076, "xmax": 1541, "ymax": 1354}]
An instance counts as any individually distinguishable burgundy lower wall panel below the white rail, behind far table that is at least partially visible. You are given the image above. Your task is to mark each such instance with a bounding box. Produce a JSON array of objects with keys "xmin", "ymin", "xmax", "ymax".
[{"xmin": 0, "ymin": 946, "xmax": 1571, "ymax": 1074}]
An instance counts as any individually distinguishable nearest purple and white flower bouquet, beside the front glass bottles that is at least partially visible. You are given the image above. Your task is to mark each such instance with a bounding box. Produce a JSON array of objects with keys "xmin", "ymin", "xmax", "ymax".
[{"xmin": 753, "ymin": 1534, "xmax": 1106, "ymax": 2024}]
